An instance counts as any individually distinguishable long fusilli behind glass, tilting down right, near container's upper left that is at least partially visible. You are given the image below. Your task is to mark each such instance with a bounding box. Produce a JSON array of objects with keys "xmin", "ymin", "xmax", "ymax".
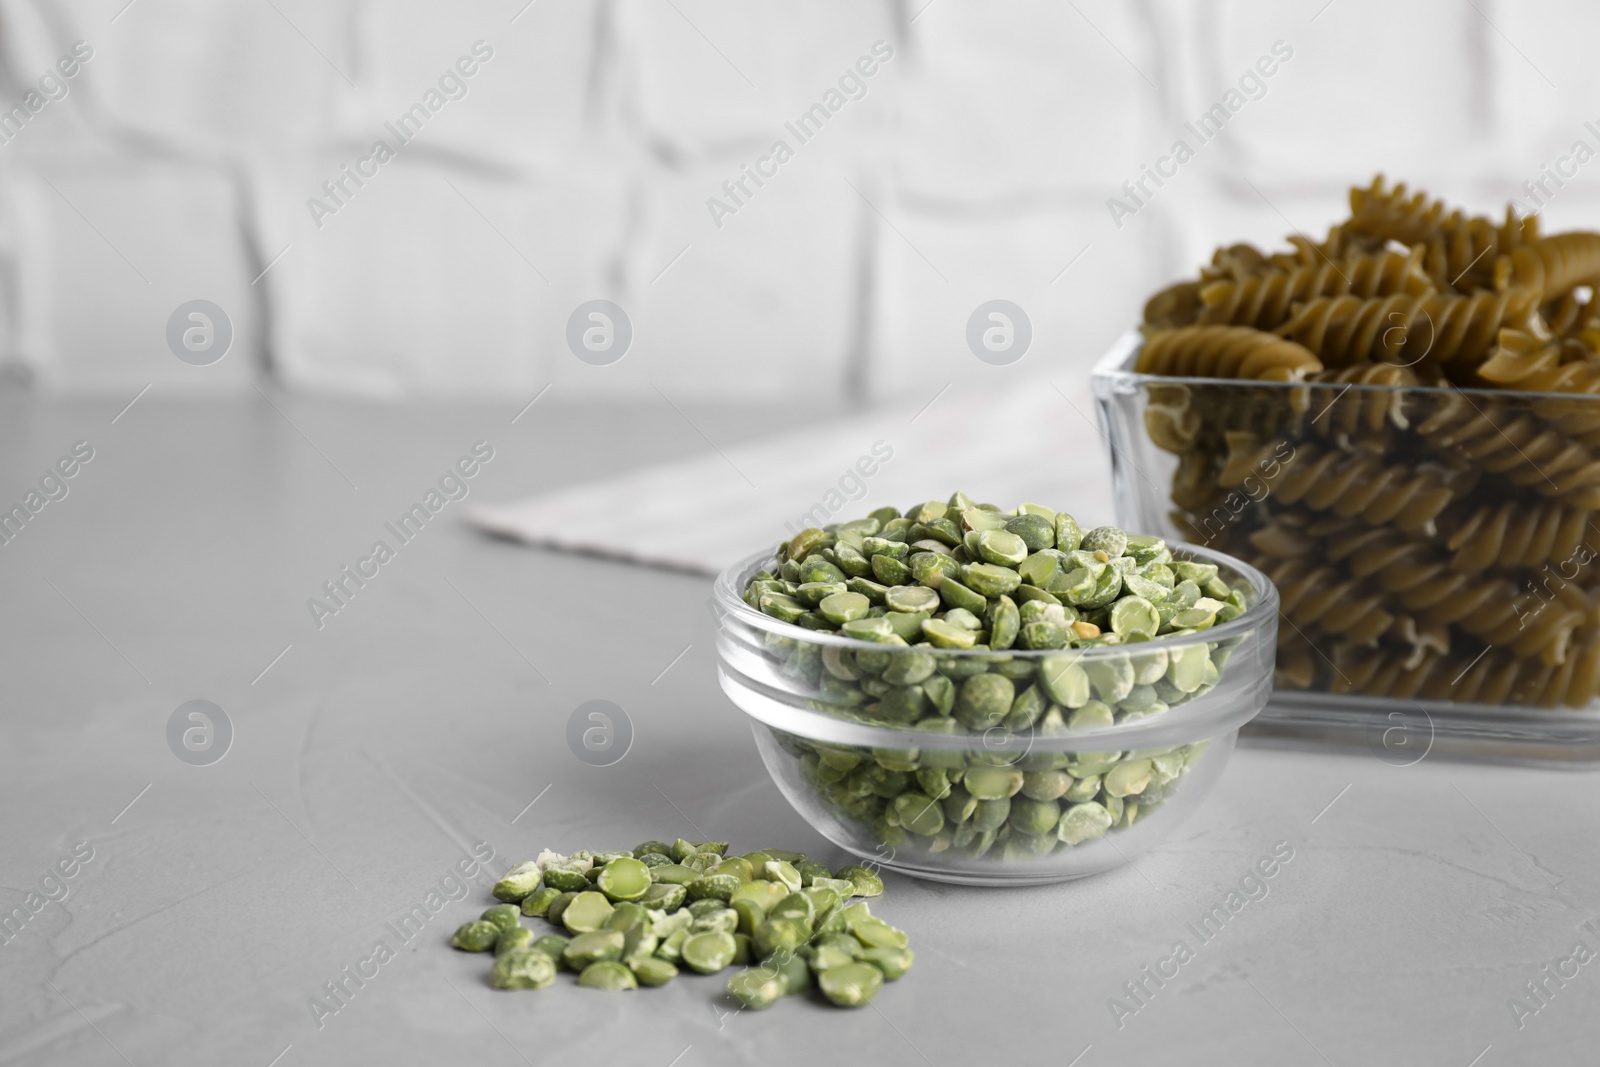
[{"xmin": 1218, "ymin": 432, "xmax": 1475, "ymax": 534}]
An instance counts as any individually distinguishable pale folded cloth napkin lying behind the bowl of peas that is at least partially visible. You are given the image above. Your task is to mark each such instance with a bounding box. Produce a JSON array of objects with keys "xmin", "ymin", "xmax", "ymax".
[{"xmin": 466, "ymin": 378, "xmax": 1112, "ymax": 574}]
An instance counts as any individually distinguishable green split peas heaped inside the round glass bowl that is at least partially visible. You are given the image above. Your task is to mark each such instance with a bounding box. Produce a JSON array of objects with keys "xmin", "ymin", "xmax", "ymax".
[{"xmin": 744, "ymin": 493, "xmax": 1250, "ymax": 861}]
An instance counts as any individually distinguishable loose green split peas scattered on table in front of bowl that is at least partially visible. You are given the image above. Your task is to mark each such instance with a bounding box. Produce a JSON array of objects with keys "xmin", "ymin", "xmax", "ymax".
[{"xmin": 450, "ymin": 838, "xmax": 912, "ymax": 1008}]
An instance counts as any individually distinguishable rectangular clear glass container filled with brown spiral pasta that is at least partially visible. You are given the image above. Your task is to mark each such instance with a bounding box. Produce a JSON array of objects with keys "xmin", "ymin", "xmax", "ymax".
[{"xmin": 1093, "ymin": 331, "xmax": 1600, "ymax": 768}]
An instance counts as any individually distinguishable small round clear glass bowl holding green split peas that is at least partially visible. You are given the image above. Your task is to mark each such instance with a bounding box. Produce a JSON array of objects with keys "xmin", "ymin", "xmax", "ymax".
[{"xmin": 714, "ymin": 545, "xmax": 1278, "ymax": 886}]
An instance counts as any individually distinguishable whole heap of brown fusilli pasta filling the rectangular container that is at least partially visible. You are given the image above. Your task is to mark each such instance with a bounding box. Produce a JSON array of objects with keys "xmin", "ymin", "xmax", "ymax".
[{"xmin": 1138, "ymin": 176, "xmax": 1600, "ymax": 707}]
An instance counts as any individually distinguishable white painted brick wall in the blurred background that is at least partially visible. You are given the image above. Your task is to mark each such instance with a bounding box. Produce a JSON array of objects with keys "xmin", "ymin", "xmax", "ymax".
[{"xmin": 0, "ymin": 0, "xmax": 1600, "ymax": 403}]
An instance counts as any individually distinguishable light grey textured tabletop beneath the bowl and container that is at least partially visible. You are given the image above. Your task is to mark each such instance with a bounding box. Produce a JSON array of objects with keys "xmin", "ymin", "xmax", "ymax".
[{"xmin": 0, "ymin": 395, "xmax": 1600, "ymax": 1067}]
